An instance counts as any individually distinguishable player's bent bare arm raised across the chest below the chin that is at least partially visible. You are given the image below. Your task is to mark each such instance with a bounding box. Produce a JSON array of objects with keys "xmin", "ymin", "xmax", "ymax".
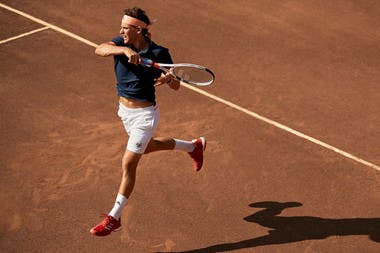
[{"xmin": 95, "ymin": 41, "xmax": 140, "ymax": 64}]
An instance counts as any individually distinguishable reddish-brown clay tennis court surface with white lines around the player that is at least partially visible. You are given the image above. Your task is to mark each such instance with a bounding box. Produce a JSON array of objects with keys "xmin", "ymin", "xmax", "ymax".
[{"xmin": 0, "ymin": 0, "xmax": 380, "ymax": 253}]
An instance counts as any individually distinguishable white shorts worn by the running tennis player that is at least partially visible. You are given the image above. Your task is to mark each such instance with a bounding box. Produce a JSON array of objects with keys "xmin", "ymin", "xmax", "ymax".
[{"xmin": 117, "ymin": 103, "xmax": 160, "ymax": 154}]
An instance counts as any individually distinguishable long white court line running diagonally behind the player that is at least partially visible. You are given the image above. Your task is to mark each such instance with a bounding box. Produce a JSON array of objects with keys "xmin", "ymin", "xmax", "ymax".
[{"xmin": 0, "ymin": 3, "xmax": 380, "ymax": 171}]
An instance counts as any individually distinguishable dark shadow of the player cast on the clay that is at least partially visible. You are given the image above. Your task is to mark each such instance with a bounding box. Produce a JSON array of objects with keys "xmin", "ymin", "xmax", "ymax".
[{"xmin": 160, "ymin": 201, "xmax": 380, "ymax": 253}]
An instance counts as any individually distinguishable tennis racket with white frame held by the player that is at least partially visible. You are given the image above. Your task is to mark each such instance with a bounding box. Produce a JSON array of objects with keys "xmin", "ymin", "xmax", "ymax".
[{"xmin": 141, "ymin": 57, "xmax": 215, "ymax": 86}]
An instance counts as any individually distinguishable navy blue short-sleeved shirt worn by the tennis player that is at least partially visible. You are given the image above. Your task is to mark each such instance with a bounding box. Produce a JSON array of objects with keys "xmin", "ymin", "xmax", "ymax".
[{"xmin": 112, "ymin": 36, "xmax": 173, "ymax": 104}]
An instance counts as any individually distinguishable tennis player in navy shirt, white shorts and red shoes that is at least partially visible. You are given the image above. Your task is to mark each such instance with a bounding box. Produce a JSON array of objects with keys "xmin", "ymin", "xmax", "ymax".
[{"xmin": 90, "ymin": 7, "xmax": 206, "ymax": 236}]
